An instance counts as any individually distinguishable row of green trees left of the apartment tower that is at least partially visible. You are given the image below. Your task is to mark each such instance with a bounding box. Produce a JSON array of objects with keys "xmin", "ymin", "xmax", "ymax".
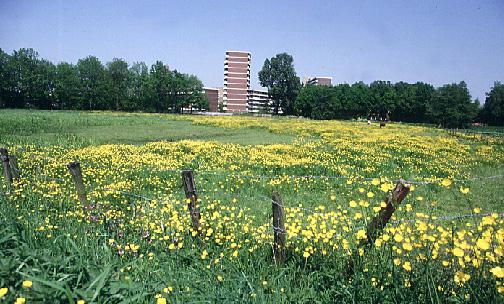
[{"xmin": 0, "ymin": 48, "xmax": 208, "ymax": 113}]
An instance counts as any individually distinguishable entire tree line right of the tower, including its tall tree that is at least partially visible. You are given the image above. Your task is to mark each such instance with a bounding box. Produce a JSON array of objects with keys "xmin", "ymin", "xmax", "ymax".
[{"xmin": 259, "ymin": 53, "xmax": 504, "ymax": 127}]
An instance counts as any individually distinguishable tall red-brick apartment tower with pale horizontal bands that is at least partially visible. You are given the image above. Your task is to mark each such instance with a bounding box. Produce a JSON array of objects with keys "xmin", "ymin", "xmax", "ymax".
[{"xmin": 222, "ymin": 51, "xmax": 250, "ymax": 112}]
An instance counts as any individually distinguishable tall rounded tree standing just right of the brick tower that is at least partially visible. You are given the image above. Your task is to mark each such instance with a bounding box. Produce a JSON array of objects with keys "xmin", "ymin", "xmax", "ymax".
[{"xmin": 259, "ymin": 53, "xmax": 300, "ymax": 115}]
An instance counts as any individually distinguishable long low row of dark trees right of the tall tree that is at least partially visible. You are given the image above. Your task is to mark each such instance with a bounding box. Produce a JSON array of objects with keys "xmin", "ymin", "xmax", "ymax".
[{"xmin": 294, "ymin": 81, "xmax": 480, "ymax": 127}]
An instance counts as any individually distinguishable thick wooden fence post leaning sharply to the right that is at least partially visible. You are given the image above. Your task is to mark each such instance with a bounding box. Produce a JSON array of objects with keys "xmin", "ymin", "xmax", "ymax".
[{"xmin": 366, "ymin": 178, "xmax": 411, "ymax": 244}]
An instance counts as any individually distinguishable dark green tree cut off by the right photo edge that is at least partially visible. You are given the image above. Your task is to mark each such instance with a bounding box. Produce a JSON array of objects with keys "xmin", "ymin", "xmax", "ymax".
[{"xmin": 481, "ymin": 81, "xmax": 504, "ymax": 126}]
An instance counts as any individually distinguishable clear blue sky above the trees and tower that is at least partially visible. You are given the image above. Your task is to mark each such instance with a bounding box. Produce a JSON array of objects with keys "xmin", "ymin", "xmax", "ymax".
[{"xmin": 0, "ymin": 0, "xmax": 504, "ymax": 101}]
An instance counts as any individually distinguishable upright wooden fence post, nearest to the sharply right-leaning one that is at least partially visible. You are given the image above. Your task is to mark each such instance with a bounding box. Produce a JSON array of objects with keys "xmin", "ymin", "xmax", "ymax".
[{"xmin": 271, "ymin": 191, "xmax": 287, "ymax": 265}]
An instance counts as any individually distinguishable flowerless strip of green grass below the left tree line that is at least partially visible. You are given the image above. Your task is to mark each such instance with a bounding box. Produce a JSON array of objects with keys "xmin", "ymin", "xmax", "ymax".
[{"xmin": 0, "ymin": 110, "xmax": 295, "ymax": 146}]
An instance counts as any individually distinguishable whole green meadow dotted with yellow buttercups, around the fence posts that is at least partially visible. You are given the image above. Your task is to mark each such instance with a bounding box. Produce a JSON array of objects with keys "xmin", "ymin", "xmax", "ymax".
[{"xmin": 0, "ymin": 110, "xmax": 504, "ymax": 304}]
